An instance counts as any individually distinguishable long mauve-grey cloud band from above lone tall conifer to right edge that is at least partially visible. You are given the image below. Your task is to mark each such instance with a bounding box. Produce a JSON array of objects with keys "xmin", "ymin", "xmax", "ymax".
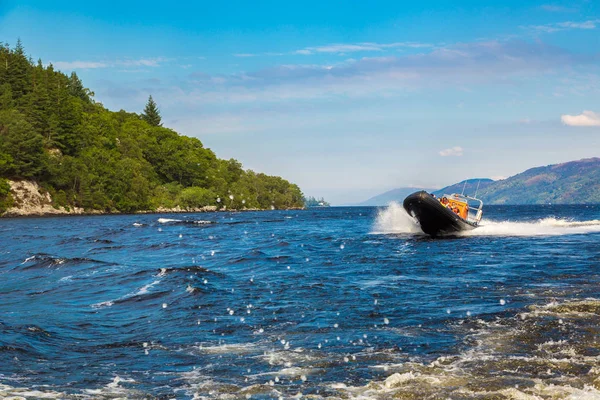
[{"xmin": 98, "ymin": 41, "xmax": 598, "ymax": 108}]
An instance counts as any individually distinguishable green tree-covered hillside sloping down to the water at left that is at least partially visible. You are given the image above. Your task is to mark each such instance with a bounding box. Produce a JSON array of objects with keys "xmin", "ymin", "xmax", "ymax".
[{"xmin": 0, "ymin": 42, "xmax": 303, "ymax": 212}]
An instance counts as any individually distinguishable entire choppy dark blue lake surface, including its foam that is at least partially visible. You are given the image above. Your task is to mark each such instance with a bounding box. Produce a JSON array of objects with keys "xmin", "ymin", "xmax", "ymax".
[{"xmin": 0, "ymin": 205, "xmax": 600, "ymax": 399}]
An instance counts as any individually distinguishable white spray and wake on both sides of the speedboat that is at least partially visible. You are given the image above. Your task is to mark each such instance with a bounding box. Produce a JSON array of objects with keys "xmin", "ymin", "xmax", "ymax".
[{"xmin": 372, "ymin": 202, "xmax": 600, "ymax": 236}]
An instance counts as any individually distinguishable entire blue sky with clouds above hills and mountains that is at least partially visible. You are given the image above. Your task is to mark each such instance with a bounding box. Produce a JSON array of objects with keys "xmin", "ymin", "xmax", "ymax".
[{"xmin": 0, "ymin": 0, "xmax": 600, "ymax": 204}]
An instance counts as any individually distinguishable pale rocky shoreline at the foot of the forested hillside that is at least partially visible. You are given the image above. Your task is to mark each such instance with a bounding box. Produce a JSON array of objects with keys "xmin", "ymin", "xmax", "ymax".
[{"xmin": 0, "ymin": 180, "xmax": 290, "ymax": 217}]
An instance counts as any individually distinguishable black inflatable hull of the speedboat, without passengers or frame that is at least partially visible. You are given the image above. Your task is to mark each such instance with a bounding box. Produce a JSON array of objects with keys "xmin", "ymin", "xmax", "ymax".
[{"xmin": 403, "ymin": 191, "xmax": 477, "ymax": 236}]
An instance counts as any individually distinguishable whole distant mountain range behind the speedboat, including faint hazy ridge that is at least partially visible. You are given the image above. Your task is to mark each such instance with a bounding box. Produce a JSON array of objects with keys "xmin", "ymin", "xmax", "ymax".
[{"xmin": 360, "ymin": 157, "xmax": 600, "ymax": 205}]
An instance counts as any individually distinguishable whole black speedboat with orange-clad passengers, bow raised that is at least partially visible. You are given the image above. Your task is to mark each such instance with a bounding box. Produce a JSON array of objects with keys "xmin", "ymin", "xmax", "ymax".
[{"xmin": 403, "ymin": 190, "xmax": 483, "ymax": 236}]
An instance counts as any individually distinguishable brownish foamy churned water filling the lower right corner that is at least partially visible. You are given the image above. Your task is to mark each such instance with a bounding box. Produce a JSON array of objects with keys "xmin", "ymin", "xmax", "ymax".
[{"xmin": 310, "ymin": 299, "xmax": 600, "ymax": 400}]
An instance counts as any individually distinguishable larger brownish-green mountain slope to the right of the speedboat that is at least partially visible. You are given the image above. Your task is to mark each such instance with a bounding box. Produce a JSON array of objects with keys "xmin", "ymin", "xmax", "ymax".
[{"xmin": 478, "ymin": 158, "xmax": 600, "ymax": 204}]
